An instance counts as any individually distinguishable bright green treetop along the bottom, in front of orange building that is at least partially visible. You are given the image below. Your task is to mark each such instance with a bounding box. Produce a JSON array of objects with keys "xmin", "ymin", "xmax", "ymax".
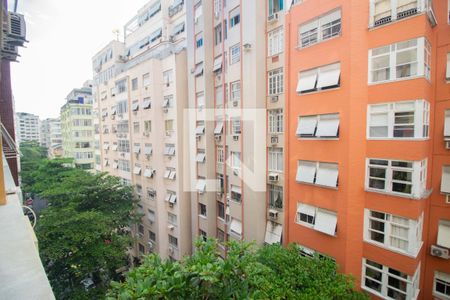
[{"xmin": 107, "ymin": 239, "xmax": 368, "ymax": 300}]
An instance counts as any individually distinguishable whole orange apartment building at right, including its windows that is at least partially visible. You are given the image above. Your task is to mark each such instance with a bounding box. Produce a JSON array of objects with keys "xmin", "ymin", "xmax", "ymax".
[{"xmin": 284, "ymin": 0, "xmax": 450, "ymax": 299}]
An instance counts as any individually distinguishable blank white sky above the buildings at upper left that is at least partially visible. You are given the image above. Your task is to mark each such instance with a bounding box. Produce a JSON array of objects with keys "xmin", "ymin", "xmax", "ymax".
[{"xmin": 9, "ymin": 0, "xmax": 149, "ymax": 119}]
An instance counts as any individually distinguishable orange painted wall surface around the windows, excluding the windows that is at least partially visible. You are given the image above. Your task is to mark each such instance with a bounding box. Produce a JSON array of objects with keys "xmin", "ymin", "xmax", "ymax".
[{"xmin": 285, "ymin": 0, "xmax": 450, "ymax": 299}]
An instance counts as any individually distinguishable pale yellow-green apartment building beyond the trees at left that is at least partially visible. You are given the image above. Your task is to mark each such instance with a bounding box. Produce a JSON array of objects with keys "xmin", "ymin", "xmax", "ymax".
[{"xmin": 61, "ymin": 81, "xmax": 94, "ymax": 170}]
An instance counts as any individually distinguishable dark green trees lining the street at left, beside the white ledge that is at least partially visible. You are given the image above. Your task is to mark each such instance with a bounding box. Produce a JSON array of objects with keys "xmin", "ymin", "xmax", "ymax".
[{"xmin": 22, "ymin": 159, "xmax": 138, "ymax": 299}]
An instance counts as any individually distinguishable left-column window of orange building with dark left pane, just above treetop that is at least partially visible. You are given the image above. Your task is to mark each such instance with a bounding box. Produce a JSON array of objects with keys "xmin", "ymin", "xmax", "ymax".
[{"xmin": 296, "ymin": 203, "xmax": 337, "ymax": 236}]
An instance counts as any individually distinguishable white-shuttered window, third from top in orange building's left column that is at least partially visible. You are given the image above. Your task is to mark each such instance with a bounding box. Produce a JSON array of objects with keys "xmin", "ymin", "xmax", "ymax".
[{"xmin": 296, "ymin": 114, "xmax": 339, "ymax": 138}]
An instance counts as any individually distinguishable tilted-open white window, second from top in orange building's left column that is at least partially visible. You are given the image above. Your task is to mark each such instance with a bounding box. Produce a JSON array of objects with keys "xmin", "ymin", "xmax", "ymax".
[{"xmin": 297, "ymin": 63, "xmax": 341, "ymax": 93}]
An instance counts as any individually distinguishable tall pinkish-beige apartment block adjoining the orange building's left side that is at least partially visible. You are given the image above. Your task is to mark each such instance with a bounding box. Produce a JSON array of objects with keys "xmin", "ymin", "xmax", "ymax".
[{"xmin": 188, "ymin": 0, "xmax": 284, "ymax": 254}]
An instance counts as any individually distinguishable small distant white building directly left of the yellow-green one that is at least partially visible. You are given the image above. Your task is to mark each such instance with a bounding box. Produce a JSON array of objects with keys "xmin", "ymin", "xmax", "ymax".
[{"xmin": 40, "ymin": 118, "xmax": 62, "ymax": 157}]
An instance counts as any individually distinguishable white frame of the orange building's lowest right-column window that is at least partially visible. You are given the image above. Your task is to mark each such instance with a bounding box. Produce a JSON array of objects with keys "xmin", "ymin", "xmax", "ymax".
[{"xmin": 361, "ymin": 258, "xmax": 420, "ymax": 299}]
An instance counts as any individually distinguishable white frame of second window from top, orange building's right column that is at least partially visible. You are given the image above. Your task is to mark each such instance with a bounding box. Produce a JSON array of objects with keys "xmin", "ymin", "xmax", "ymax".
[{"xmin": 369, "ymin": 37, "xmax": 431, "ymax": 84}]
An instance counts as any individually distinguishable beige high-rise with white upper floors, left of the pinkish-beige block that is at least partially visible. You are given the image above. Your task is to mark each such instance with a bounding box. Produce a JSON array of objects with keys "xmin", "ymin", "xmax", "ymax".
[{"xmin": 93, "ymin": 0, "xmax": 192, "ymax": 260}]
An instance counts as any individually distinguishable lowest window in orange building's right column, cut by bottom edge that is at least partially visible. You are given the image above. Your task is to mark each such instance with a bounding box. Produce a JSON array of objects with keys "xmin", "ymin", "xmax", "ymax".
[{"xmin": 361, "ymin": 258, "xmax": 420, "ymax": 299}]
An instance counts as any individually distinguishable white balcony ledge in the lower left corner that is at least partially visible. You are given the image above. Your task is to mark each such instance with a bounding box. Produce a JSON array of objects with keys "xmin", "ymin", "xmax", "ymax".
[{"xmin": 0, "ymin": 151, "xmax": 55, "ymax": 299}]
